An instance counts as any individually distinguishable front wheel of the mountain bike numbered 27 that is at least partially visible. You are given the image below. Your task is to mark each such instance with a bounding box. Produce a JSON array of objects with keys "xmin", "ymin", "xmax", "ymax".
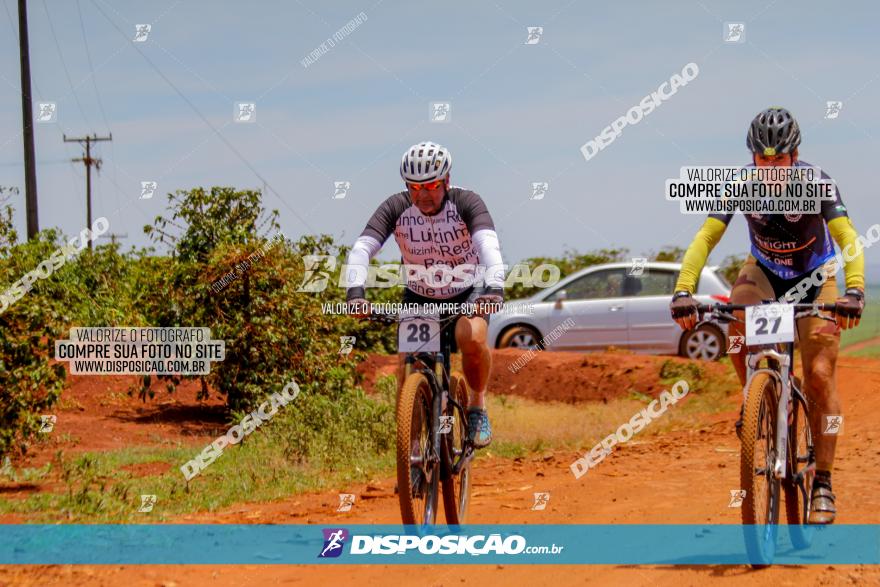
[{"xmin": 740, "ymin": 372, "xmax": 781, "ymax": 568}]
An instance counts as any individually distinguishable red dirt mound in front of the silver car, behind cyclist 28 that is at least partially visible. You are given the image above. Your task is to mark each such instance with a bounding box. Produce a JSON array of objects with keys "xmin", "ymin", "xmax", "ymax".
[{"xmin": 358, "ymin": 349, "xmax": 727, "ymax": 403}]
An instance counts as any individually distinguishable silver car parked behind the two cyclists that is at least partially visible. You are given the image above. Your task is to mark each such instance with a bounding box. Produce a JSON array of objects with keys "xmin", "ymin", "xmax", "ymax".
[{"xmin": 489, "ymin": 262, "xmax": 730, "ymax": 360}]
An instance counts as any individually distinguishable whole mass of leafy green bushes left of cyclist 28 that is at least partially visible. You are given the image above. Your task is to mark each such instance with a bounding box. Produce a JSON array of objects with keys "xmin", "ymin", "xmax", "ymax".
[{"xmin": 0, "ymin": 187, "xmax": 395, "ymax": 457}]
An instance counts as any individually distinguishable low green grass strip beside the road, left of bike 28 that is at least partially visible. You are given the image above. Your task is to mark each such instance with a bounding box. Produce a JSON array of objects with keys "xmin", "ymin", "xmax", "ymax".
[{"xmin": 0, "ymin": 440, "xmax": 394, "ymax": 523}]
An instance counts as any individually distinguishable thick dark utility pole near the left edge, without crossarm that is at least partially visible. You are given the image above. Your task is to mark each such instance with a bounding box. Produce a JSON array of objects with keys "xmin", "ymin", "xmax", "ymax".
[{"xmin": 18, "ymin": 0, "xmax": 39, "ymax": 242}]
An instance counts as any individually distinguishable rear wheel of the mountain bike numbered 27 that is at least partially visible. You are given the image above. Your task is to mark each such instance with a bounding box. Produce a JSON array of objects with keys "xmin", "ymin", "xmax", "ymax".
[{"xmin": 782, "ymin": 382, "xmax": 816, "ymax": 549}]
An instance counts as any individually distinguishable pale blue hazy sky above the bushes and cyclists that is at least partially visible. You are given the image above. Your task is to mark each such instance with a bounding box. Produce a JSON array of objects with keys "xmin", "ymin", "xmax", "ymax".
[{"xmin": 0, "ymin": 0, "xmax": 880, "ymax": 276}]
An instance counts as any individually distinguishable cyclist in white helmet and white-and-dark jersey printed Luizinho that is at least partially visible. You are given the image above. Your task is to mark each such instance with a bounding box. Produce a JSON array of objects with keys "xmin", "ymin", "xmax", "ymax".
[{"xmin": 346, "ymin": 142, "xmax": 504, "ymax": 448}]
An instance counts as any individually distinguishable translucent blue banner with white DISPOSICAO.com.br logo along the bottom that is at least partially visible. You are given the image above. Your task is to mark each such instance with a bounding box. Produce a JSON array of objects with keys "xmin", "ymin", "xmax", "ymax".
[{"xmin": 0, "ymin": 524, "xmax": 880, "ymax": 565}]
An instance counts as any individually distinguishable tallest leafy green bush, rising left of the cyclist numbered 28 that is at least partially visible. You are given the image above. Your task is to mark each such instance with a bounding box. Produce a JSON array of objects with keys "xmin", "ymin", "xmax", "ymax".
[{"xmin": 145, "ymin": 187, "xmax": 368, "ymax": 411}]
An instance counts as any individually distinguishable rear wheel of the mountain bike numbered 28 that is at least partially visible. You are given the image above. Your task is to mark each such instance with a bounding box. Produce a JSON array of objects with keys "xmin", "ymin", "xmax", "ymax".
[{"xmin": 441, "ymin": 373, "xmax": 471, "ymax": 525}]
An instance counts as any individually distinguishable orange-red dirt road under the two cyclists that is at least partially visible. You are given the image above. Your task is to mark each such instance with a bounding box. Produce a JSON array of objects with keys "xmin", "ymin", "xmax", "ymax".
[{"xmin": 0, "ymin": 358, "xmax": 880, "ymax": 587}]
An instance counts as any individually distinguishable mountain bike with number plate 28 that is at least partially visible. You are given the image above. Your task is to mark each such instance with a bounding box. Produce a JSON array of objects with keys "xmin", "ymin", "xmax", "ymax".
[{"xmin": 367, "ymin": 314, "xmax": 474, "ymax": 526}]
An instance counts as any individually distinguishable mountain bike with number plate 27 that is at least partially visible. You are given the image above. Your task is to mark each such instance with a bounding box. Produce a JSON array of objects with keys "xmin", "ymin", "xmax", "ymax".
[{"xmin": 699, "ymin": 303, "xmax": 835, "ymax": 568}]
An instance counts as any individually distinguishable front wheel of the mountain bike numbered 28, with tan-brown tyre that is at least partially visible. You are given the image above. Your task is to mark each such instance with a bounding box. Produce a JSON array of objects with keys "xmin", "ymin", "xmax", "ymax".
[{"xmin": 397, "ymin": 373, "xmax": 440, "ymax": 526}]
